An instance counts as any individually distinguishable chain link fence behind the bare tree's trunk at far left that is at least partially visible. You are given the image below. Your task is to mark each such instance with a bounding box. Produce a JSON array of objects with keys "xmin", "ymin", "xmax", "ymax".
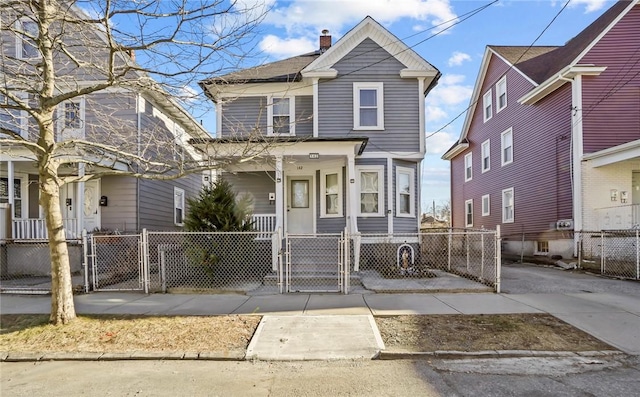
[{"xmin": 0, "ymin": 239, "xmax": 87, "ymax": 294}]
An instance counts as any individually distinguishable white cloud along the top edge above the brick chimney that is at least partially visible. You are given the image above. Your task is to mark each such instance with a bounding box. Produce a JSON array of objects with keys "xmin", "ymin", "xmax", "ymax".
[{"xmin": 266, "ymin": 0, "xmax": 456, "ymax": 34}]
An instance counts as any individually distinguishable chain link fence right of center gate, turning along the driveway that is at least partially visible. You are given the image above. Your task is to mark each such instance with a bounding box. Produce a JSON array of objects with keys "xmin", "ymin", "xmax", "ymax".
[{"xmin": 360, "ymin": 229, "xmax": 500, "ymax": 291}]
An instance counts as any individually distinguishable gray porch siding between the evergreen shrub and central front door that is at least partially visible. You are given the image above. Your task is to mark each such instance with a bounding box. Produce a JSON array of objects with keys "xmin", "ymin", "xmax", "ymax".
[{"xmin": 222, "ymin": 171, "xmax": 276, "ymax": 214}]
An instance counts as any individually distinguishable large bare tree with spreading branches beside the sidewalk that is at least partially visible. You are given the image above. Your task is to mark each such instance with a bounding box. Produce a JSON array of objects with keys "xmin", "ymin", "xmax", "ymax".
[{"xmin": 0, "ymin": 0, "xmax": 266, "ymax": 324}]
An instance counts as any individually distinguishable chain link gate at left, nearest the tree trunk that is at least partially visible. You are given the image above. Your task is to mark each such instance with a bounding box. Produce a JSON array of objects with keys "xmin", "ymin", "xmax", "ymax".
[{"xmin": 89, "ymin": 234, "xmax": 149, "ymax": 292}]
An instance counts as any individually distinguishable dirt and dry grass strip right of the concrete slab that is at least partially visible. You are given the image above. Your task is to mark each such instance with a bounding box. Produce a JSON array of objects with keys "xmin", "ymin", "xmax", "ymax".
[{"xmin": 376, "ymin": 314, "xmax": 615, "ymax": 352}]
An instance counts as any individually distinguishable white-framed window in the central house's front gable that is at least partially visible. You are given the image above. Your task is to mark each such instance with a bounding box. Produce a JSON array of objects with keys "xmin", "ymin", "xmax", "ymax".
[{"xmin": 353, "ymin": 83, "xmax": 384, "ymax": 130}]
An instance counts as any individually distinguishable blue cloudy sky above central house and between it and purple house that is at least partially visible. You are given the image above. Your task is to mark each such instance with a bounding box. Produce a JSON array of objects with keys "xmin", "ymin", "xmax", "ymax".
[{"xmin": 195, "ymin": 0, "xmax": 615, "ymax": 212}]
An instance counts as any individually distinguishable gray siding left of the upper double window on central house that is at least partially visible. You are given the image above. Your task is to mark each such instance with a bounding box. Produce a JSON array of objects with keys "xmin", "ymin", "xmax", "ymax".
[{"xmin": 222, "ymin": 96, "xmax": 267, "ymax": 137}]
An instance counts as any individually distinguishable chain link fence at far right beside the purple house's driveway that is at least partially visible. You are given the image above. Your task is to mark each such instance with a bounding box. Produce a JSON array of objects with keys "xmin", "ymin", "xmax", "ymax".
[{"xmin": 576, "ymin": 229, "xmax": 640, "ymax": 280}]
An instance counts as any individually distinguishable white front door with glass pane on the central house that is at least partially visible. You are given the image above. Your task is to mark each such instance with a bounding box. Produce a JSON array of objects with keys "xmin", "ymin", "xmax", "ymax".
[{"xmin": 286, "ymin": 176, "xmax": 314, "ymax": 234}]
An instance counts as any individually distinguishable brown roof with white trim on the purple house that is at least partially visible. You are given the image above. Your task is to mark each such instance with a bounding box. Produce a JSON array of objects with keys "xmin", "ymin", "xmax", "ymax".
[{"xmin": 442, "ymin": 0, "xmax": 640, "ymax": 160}]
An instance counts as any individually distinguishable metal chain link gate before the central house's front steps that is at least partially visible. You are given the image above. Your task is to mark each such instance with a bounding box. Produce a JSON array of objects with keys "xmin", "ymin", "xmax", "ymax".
[{"xmin": 280, "ymin": 233, "xmax": 350, "ymax": 294}]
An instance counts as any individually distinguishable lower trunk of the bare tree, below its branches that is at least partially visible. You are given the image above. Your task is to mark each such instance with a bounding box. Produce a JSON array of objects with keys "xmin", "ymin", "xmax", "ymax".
[{"xmin": 40, "ymin": 172, "xmax": 76, "ymax": 324}]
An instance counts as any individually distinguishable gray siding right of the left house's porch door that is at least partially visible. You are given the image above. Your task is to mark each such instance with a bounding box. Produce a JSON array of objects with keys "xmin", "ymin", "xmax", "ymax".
[{"xmin": 100, "ymin": 176, "xmax": 139, "ymax": 231}]
